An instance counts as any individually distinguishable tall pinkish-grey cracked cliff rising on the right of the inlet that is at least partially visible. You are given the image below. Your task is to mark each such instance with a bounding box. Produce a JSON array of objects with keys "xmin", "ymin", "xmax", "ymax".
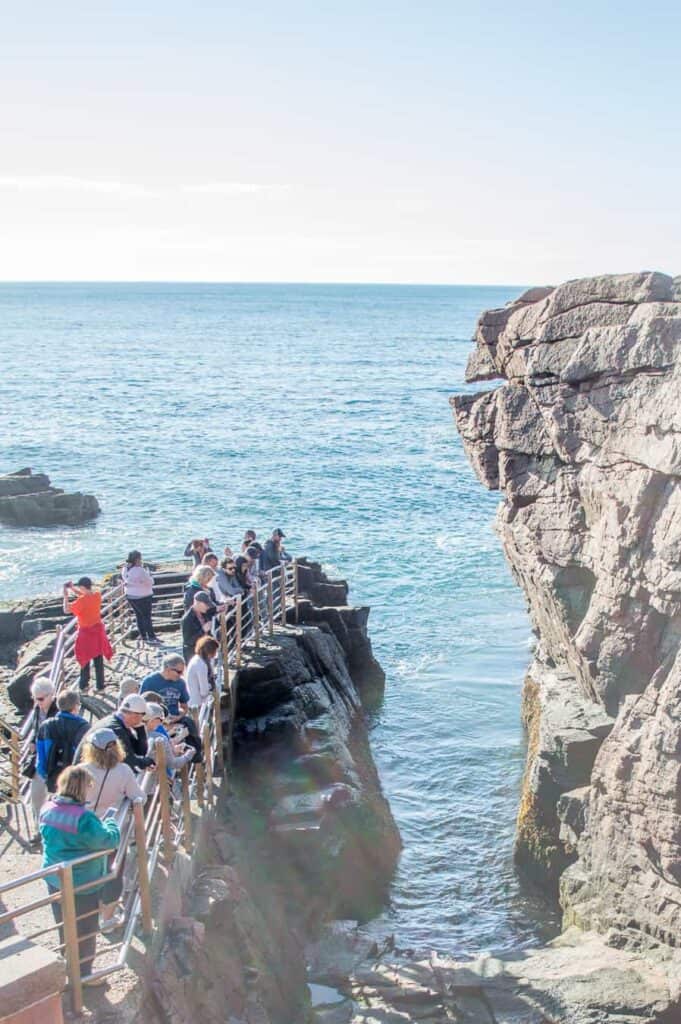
[{"xmin": 453, "ymin": 272, "xmax": 681, "ymax": 958}]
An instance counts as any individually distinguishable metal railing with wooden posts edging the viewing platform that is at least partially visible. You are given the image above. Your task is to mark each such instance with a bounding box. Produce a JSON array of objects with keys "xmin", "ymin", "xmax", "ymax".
[{"xmin": 0, "ymin": 562, "xmax": 298, "ymax": 1013}]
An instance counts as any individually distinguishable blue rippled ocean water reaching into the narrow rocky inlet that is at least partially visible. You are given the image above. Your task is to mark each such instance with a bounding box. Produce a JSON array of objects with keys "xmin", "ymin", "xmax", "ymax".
[{"xmin": 0, "ymin": 284, "xmax": 551, "ymax": 952}]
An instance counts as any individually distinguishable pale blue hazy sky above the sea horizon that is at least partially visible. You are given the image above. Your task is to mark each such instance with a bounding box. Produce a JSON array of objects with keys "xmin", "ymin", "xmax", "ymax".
[{"xmin": 0, "ymin": 0, "xmax": 681, "ymax": 285}]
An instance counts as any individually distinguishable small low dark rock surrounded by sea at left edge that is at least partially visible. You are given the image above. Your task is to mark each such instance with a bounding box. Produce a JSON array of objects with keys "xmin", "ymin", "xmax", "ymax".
[{"xmin": 0, "ymin": 469, "xmax": 100, "ymax": 526}]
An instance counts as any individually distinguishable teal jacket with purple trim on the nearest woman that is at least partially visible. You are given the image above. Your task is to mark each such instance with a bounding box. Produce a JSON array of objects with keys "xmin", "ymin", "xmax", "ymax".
[{"xmin": 40, "ymin": 797, "xmax": 121, "ymax": 892}]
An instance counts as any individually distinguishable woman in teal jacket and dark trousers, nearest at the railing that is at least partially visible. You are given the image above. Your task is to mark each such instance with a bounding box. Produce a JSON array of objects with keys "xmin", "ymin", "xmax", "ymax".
[{"xmin": 40, "ymin": 765, "xmax": 121, "ymax": 984}]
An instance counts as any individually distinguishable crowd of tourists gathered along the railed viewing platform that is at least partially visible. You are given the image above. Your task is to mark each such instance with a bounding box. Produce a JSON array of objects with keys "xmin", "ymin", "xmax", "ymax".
[{"xmin": 22, "ymin": 529, "xmax": 291, "ymax": 983}]
